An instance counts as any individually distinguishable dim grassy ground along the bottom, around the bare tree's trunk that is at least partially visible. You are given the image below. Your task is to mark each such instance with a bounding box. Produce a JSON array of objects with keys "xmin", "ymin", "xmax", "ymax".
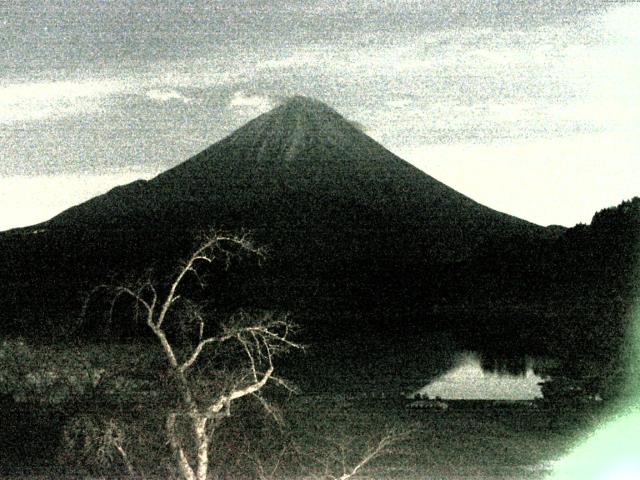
[{"xmin": 0, "ymin": 388, "xmax": 602, "ymax": 480}]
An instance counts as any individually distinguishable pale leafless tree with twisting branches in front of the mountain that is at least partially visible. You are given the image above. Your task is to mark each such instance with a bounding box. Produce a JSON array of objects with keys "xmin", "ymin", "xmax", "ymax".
[{"xmin": 85, "ymin": 233, "xmax": 301, "ymax": 480}]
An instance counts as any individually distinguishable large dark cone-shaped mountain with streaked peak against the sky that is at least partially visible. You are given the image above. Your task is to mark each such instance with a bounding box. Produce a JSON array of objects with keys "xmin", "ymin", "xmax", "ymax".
[{"xmin": 0, "ymin": 97, "xmax": 548, "ymax": 342}]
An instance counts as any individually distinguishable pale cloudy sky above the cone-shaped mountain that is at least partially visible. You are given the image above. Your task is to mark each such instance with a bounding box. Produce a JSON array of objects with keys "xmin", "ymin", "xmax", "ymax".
[{"xmin": 0, "ymin": 0, "xmax": 640, "ymax": 230}]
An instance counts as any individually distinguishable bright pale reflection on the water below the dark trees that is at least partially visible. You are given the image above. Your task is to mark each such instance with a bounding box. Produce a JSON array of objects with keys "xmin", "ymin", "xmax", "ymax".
[{"xmin": 416, "ymin": 353, "xmax": 544, "ymax": 400}]
